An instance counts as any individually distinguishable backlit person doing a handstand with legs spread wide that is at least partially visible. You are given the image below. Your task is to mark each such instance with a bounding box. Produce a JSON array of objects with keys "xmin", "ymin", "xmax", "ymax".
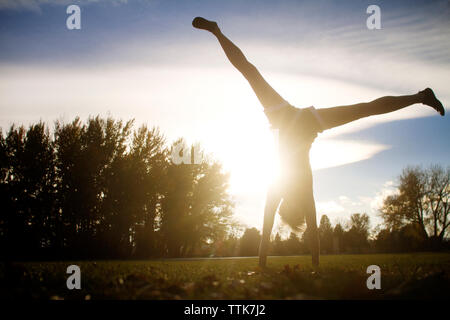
[{"xmin": 192, "ymin": 17, "xmax": 445, "ymax": 267}]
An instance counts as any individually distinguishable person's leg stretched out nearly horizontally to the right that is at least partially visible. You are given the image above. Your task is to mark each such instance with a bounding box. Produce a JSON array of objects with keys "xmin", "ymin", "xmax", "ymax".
[{"xmin": 316, "ymin": 88, "xmax": 445, "ymax": 129}]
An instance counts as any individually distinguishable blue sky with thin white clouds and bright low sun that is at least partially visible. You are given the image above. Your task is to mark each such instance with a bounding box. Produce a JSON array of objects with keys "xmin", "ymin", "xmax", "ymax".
[{"xmin": 0, "ymin": 0, "xmax": 450, "ymax": 235}]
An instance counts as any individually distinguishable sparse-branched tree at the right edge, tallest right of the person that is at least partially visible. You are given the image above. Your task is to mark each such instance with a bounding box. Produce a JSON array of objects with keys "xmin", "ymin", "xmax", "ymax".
[{"xmin": 380, "ymin": 165, "xmax": 450, "ymax": 245}]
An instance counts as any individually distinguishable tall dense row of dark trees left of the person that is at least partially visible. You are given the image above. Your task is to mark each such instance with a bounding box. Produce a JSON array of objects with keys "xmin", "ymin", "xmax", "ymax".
[{"xmin": 0, "ymin": 116, "xmax": 233, "ymax": 259}]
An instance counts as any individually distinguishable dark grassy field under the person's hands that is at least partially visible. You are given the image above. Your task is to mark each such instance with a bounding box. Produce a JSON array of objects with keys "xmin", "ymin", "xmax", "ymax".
[{"xmin": 0, "ymin": 253, "xmax": 450, "ymax": 299}]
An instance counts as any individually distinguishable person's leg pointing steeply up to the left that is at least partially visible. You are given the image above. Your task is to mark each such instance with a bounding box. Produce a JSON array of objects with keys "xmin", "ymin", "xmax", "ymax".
[{"xmin": 192, "ymin": 17, "xmax": 286, "ymax": 108}]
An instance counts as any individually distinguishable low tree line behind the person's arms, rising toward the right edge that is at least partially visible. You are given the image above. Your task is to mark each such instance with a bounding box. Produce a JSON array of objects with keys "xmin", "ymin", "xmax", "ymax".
[{"xmin": 222, "ymin": 165, "xmax": 450, "ymax": 256}]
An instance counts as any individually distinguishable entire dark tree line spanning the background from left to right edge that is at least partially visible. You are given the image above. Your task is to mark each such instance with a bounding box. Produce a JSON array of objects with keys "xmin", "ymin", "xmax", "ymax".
[{"xmin": 0, "ymin": 116, "xmax": 450, "ymax": 259}]
